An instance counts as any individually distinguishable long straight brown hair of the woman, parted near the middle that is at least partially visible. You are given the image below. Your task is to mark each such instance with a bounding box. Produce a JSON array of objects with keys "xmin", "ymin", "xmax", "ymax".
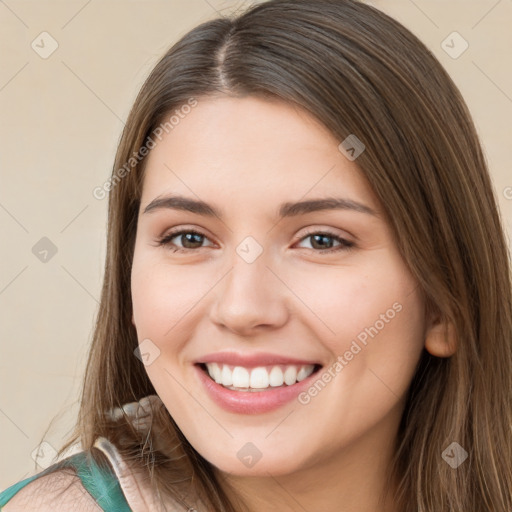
[{"xmin": 53, "ymin": 0, "xmax": 512, "ymax": 512}]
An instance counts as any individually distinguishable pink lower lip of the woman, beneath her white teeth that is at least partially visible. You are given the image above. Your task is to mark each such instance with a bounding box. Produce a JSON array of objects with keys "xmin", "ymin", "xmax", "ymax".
[{"xmin": 194, "ymin": 365, "xmax": 318, "ymax": 414}]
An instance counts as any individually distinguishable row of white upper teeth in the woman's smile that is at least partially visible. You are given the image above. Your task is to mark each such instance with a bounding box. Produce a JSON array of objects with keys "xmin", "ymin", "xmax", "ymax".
[{"xmin": 206, "ymin": 363, "xmax": 315, "ymax": 391}]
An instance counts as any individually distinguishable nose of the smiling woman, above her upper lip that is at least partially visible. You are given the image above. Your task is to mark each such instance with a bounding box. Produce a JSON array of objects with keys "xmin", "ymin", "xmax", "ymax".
[{"xmin": 210, "ymin": 249, "xmax": 292, "ymax": 336}]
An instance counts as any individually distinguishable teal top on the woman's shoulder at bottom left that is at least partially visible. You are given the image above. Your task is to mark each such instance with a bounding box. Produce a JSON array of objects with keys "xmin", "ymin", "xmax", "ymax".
[{"xmin": 0, "ymin": 452, "xmax": 132, "ymax": 512}]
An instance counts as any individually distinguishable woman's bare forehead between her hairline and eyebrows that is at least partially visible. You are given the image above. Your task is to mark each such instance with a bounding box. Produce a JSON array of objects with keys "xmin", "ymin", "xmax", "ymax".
[{"xmin": 142, "ymin": 96, "xmax": 379, "ymax": 214}]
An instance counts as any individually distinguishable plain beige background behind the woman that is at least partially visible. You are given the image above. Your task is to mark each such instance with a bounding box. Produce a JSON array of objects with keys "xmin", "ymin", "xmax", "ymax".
[{"xmin": 0, "ymin": 0, "xmax": 512, "ymax": 490}]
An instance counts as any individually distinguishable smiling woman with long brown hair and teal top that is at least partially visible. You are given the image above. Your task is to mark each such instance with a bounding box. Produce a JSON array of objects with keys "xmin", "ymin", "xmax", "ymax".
[{"xmin": 0, "ymin": 0, "xmax": 512, "ymax": 512}]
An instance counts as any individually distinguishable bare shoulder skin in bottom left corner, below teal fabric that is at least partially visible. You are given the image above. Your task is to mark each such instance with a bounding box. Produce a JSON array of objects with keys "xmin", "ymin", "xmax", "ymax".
[{"xmin": 2, "ymin": 468, "xmax": 102, "ymax": 512}]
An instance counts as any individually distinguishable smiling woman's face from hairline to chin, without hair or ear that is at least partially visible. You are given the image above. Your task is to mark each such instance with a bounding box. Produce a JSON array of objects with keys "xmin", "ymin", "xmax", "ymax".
[{"xmin": 132, "ymin": 97, "xmax": 425, "ymax": 475}]
